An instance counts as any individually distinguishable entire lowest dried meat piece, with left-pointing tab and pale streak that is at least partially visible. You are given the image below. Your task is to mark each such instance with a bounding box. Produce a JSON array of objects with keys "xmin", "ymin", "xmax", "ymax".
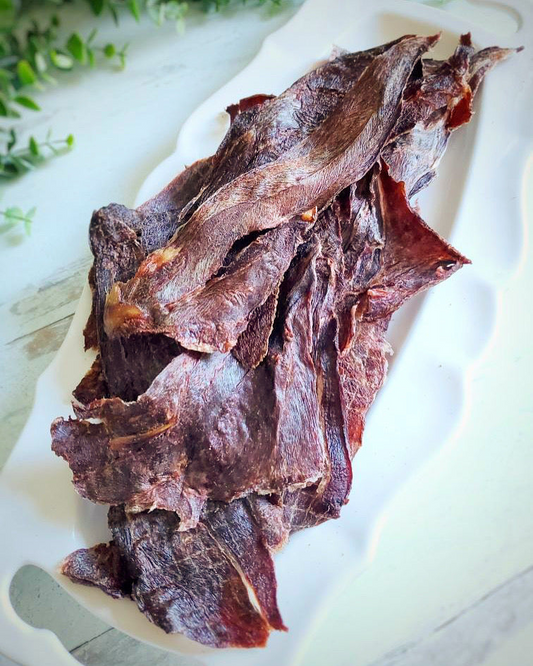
[{"xmin": 61, "ymin": 501, "xmax": 286, "ymax": 647}]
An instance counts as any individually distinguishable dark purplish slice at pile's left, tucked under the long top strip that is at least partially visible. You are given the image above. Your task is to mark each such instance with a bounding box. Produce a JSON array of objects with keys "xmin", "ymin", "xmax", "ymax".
[{"xmin": 82, "ymin": 154, "xmax": 209, "ymax": 400}]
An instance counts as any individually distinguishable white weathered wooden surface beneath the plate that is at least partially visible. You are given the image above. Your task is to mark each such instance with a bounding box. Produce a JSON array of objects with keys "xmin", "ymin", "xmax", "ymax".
[{"xmin": 0, "ymin": 0, "xmax": 533, "ymax": 666}]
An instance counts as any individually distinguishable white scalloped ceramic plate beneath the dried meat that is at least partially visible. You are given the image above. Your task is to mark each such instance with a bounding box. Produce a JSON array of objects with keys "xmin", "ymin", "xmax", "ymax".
[{"xmin": 0, "ymin": 0, "xmax": 533, "ymax": 666}]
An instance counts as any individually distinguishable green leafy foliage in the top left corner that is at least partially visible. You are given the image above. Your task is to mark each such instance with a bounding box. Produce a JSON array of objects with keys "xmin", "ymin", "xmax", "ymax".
[{"xmin": 0, "ymin": 0, "xmax": 283, "ymax": 235}]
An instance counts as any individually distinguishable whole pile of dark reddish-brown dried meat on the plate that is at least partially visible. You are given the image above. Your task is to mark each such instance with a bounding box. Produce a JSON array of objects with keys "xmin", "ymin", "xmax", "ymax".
[{"xmin": 52, "ymin": 35, "xmax": 512, "ymax": 648}]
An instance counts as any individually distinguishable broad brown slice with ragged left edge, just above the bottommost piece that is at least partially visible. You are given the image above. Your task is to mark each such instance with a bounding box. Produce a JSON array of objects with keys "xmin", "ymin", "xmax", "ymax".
[{"xmin": 52, "ymin": 239, "xmax": 326, "ymax": 512}]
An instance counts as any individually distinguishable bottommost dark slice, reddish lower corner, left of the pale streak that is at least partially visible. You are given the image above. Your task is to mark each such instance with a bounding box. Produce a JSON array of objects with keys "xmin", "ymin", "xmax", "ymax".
[{"xmin": 109, "ymin": 507, "xmax": 271, "ymax": 648}]
